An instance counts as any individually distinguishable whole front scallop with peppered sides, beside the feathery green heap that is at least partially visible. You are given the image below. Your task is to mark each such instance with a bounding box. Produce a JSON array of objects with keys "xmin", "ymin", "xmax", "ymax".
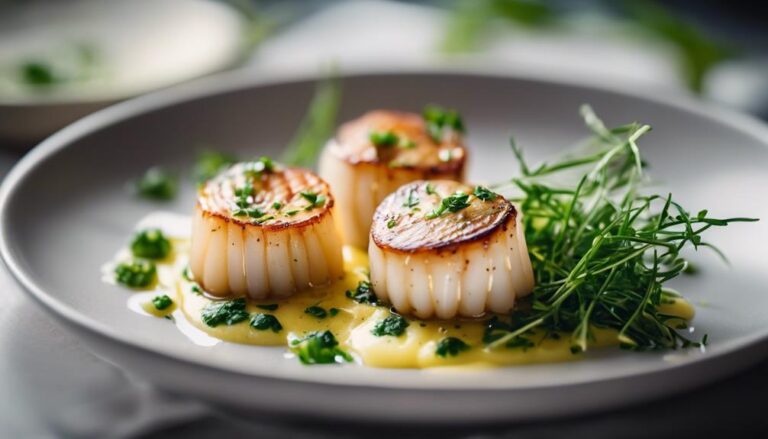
[{"xmin": 368, "ymin": 180, "xmax": 534, "ymax": 319}]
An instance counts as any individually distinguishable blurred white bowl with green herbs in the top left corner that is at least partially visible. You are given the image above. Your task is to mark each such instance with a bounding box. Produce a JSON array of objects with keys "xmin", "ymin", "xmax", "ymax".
[{"xmin": 0, "ymin": 0, "xmax": 246, "ymax": 146}]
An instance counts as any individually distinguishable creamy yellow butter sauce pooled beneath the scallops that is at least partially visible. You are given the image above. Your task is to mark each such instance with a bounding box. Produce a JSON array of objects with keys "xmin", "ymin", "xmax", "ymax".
[{"xmin": 121, "ymin": 235, "xmax": 693, "ymax": 368}]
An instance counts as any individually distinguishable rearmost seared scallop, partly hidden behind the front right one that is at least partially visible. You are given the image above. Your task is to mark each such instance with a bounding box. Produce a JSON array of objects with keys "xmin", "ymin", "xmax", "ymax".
[{"xmin": 320, "ymin": 108, "xmax": 466, "ymax": 248}]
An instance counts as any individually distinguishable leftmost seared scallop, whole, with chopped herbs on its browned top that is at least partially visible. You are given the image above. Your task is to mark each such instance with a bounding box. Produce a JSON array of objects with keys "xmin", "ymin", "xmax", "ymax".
[{"xmin": 190, "ymin": 158, "xmax": 343, "ymax": 299}]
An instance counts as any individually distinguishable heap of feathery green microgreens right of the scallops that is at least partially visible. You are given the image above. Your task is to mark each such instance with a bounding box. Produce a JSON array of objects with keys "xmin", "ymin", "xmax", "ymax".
[{"xmin": 489, "ymin": 106, "xmax": 756, "ymax": 352}]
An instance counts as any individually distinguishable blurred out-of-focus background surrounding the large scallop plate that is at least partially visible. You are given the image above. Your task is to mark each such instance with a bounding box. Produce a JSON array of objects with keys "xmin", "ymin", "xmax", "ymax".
[{"xmin": 0, "ymin": 0, "xmax": 768, "ymax": 437}]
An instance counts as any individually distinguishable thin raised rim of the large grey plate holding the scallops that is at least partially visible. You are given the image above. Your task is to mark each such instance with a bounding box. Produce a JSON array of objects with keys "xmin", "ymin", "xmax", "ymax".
[{"xmin": 0, "ymin": 66, "xmax": 768, "ymax": 392}]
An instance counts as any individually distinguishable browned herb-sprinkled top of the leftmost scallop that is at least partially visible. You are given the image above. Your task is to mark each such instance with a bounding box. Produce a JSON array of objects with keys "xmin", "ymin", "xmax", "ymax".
[{"xmin": 197, "ymin": 162, "xmax": 333, "ymax": 230}]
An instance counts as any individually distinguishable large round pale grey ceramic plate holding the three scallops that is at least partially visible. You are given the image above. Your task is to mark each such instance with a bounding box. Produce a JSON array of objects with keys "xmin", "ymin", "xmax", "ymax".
[{"xmin": 0, "ymin": 71, "xmax": 768, "ymax": 422}]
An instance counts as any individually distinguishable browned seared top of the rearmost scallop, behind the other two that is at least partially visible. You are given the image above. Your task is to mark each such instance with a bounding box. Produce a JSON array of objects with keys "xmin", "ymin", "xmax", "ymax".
[{"xmin": 328, "ymin": 110, "xmax": 467, "ymax": 177}]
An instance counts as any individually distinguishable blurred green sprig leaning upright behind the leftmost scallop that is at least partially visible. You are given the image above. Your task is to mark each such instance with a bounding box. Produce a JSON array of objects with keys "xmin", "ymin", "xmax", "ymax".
[{"xmin": 280, "ymin": 78, "xmax": 341, "ymax": 167}]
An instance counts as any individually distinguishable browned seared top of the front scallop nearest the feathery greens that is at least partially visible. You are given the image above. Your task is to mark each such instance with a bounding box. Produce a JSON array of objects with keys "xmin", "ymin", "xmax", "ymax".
[{"xmin": 371, "ymin": 180, "xmax": 517, "ymax": 253}]
